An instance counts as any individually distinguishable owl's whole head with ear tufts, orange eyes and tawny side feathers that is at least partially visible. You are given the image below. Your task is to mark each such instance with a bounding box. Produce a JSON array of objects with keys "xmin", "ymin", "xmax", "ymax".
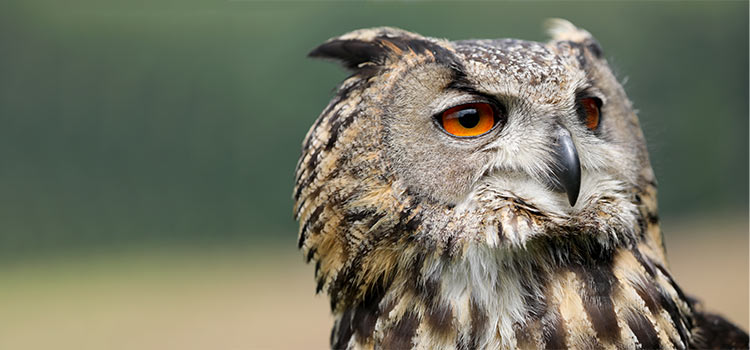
[{"xmin": 294, "ymin": 20, "xmax": 656, "ymax": 310}]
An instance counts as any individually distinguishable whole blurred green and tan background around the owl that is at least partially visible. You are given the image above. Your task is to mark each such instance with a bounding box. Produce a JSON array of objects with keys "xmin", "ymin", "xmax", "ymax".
[{"xmin": 0, "ymin": 0, "xmax": 748, "ymax": 349}]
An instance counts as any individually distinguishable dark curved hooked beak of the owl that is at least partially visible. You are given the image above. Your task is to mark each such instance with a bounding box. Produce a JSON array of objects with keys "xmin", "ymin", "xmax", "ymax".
[{"xmin": 552, "ymin": 125, "xmax": 581, "ymax": 207}]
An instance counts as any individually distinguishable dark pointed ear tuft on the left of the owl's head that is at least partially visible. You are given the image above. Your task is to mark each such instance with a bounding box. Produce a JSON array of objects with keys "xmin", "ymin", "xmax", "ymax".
[{"xmin": 308, "ymin": 27, "xmax": 425, "ymax": 70}]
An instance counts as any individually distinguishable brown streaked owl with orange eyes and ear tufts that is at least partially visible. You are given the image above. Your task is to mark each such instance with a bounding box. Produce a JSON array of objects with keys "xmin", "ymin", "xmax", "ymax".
[{"xmin": 293, "ymin": 20, "xmax": 748, "ymax": 349}]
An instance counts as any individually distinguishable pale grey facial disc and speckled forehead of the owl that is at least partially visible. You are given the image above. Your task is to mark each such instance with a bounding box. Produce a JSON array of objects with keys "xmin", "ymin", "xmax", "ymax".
[{"xmin": 382, "ymin": 34, "xmax": 647, "ymax": 216}]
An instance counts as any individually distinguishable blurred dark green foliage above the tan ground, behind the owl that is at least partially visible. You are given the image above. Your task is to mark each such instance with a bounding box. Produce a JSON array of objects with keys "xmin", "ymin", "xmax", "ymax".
[{"xmin": 0, "ymin": 0, "xmax": 748, "ymax": 258}]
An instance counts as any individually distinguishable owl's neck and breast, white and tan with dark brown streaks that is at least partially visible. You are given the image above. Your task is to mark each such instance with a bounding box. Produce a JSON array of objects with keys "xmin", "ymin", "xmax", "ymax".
[{"xmin": 331, "ymin": 224, "xmax": 692, "ymax": 349}]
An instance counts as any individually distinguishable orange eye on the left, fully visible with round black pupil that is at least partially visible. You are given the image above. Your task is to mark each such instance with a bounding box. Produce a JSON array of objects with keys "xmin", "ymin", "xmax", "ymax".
[{"xmin": 440, "ymin": 103, "xmax": 496, "ymax": 137}]
